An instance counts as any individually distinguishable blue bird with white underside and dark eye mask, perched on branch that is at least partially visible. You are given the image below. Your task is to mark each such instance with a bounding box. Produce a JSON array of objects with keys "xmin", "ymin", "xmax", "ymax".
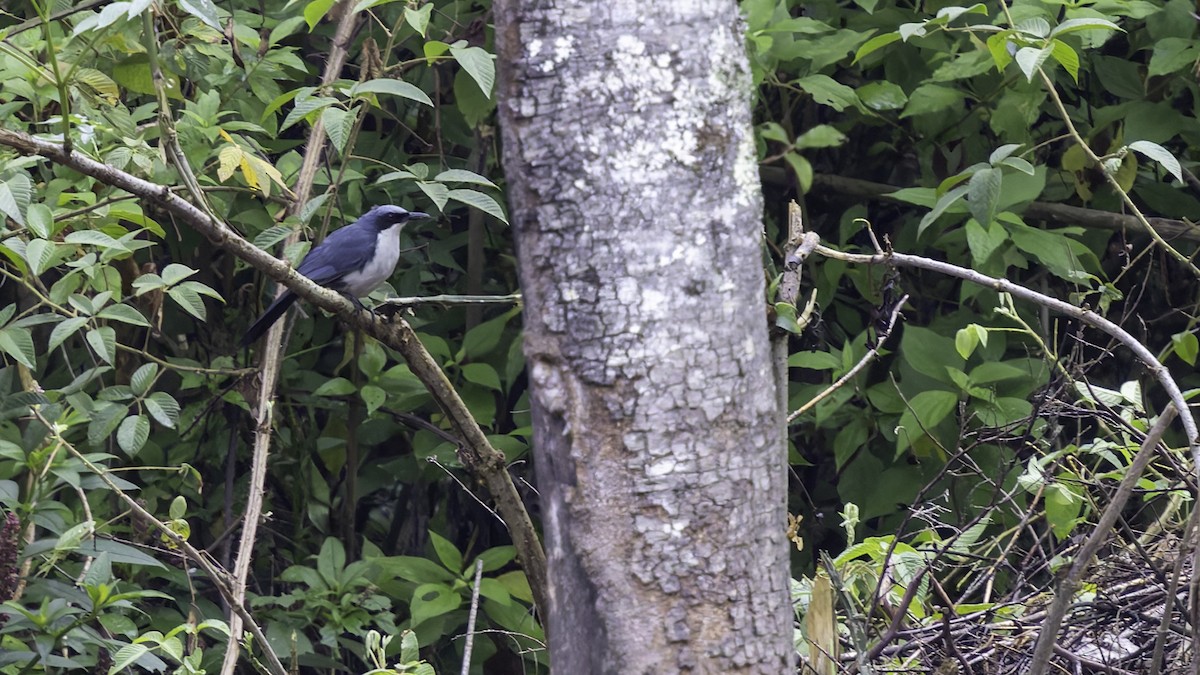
[{"xmin": 240, "ymin": 204, "xmax": 430, "ymax": 348}]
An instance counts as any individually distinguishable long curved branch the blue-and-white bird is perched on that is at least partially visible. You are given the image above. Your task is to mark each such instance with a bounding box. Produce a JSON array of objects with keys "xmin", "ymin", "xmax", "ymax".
[{"xmin": 0, "ymin": 123, "xmax": 547, "ymax": 608}]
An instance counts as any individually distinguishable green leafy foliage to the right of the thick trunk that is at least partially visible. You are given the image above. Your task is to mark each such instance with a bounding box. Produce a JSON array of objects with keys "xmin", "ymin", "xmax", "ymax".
[{"xmin": 758, "ymin": 0, "xmax": 1200, "ymax": 667}]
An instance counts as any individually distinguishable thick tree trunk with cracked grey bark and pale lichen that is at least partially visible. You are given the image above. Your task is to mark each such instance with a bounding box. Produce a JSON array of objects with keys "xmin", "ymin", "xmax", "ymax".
[{"xmin": 496, "ymin": 0, "xmax": 792, "ymax": 675}]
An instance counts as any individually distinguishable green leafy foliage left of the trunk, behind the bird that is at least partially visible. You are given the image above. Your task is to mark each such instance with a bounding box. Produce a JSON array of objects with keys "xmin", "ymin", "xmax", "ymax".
[{"xmin": 0, "ymin": 0, "xmax": 530, "ymax": 673}]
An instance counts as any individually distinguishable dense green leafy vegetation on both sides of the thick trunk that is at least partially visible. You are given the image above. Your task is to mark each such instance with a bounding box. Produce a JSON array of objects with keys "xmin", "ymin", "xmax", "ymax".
[{"xmin": 0, "ymin": 0, "xmax": 1200, "ymax": 673}]
